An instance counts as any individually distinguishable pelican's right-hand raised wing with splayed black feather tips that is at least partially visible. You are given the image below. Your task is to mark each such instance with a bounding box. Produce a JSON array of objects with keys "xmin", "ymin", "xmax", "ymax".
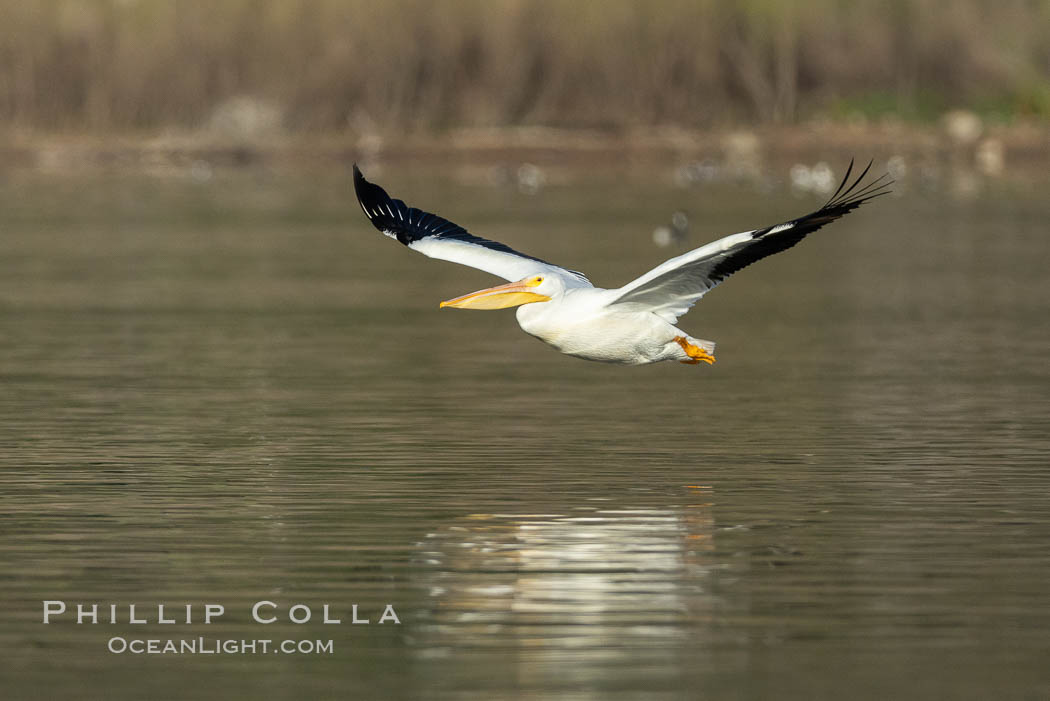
[{"xmin": 609, "ymin": 161, "xmax": 893, "ymax": 323}]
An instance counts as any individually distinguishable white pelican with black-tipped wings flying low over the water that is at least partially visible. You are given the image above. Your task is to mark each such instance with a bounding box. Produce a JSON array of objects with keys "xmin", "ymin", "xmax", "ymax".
[{"xmin": 354, "ymin": 161, "xmax": 891, "ymax": 365}]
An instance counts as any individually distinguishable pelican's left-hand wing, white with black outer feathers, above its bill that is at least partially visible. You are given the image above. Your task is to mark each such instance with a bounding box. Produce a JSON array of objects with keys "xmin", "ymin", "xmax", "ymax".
[{"xmin": 354, "ymin": 164, "xmax": 587, "ymax": 281}]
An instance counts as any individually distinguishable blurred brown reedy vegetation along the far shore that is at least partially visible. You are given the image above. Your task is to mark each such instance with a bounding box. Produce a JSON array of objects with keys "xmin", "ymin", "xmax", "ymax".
[{"xmin": 0, "ymin": 0, "xmax": 1050, "ymax": 134}]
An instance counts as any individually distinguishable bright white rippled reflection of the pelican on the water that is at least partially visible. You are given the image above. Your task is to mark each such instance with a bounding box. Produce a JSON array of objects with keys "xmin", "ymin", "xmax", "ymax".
[{"xmin": 420, "ymin": 487, "xmax": 718, "ymax": 677}]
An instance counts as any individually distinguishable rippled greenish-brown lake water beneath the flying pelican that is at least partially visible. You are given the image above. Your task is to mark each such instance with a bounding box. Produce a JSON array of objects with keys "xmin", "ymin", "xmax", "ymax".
[{"xmin": 0, "ymin": 168, "xmax": 1050, "ymax": 700}]
